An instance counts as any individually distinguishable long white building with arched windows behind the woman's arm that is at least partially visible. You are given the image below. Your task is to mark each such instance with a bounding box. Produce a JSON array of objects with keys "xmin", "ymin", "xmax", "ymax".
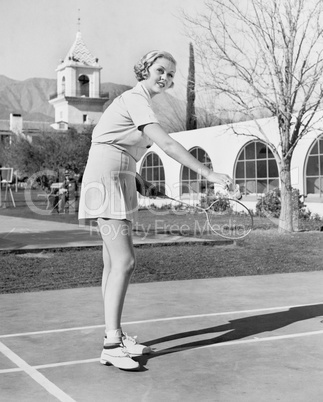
[{"xmin": 137, "ymin": 118, "xmax": 323, "ymax": 216}]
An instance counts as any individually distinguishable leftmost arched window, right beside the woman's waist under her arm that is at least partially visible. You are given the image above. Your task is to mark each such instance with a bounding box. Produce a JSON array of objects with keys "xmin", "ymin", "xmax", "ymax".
[{"xmin": 140, "ymin": 152, "xmax": 165, "ymax": 192}]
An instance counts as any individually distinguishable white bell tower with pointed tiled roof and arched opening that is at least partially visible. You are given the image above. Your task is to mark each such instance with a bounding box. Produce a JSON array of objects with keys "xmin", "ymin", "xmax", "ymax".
[{"xmin": 49, "ymin": 31, "xmax": 108, "ymax": 130}]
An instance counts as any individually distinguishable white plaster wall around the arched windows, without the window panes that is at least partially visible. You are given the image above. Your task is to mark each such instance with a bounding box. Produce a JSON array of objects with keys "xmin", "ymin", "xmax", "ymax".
[{"xmin": 137, "ymin": 118, "xmax": 323, "ymax": 216}]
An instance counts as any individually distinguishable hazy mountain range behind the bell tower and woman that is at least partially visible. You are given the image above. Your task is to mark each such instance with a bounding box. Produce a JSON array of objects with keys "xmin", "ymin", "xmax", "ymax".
[{"xmin": 0, "ymin": 75, "xmax": 190, "ymax": 131}]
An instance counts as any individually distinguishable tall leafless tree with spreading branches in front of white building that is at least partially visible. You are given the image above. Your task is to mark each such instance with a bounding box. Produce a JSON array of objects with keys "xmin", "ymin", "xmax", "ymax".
[{"xmin": 184, "ymin": 0, "xmax": 323, "ymax": 232}]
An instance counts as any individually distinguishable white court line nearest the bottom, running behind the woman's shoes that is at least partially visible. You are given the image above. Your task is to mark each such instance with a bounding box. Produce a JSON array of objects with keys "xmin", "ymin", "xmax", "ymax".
[{"xmin": 0, "ymin": 330, "xmax": 323, "ymax": 374}]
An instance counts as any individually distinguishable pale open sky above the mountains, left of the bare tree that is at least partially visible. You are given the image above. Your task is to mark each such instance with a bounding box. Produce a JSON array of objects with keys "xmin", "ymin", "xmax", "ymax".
[{"xmin": 0, "ymin": 0, "xmax": 204, "ymax": 97}]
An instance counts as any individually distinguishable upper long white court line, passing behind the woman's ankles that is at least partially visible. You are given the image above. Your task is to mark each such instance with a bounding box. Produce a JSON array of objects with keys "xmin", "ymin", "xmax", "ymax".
[{"xmin": 0, "ymin": 301, "xmax": 323, "ymax": 339}]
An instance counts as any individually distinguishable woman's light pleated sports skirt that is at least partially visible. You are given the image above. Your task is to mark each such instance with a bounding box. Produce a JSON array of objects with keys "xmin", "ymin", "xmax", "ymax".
[{"xmin": 78, "ymin": 144, "xmax": 138, "ymax": 221}]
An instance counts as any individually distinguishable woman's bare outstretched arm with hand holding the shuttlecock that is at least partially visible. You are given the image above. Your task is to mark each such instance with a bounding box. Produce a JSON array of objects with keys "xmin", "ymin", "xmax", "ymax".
[{"xmin": 143, "ymin": 123, "xmax": 232, "ymax": 187}]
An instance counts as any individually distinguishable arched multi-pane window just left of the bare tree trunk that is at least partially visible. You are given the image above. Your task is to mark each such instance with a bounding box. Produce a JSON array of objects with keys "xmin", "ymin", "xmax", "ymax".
[{"xmin": 235, "ymin": 141, "xmax": 279, "ymax": 195}]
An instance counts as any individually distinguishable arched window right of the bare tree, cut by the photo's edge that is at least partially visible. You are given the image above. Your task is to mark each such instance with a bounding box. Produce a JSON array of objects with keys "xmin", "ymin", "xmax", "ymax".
[{"xmin": 305, "ymin": 136, "xmax": 323, "ymax": 197}]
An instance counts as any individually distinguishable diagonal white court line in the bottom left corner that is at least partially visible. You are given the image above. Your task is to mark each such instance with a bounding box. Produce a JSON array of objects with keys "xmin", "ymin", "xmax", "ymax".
[{"xmin": 0, "ymin": 342, "xmax": 75, "ymax": 402}]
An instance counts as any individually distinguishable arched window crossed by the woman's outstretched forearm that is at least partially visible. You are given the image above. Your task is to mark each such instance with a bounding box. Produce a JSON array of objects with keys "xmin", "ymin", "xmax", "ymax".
[{"xmin": 181, "ymin": 147, "xmax": 213, "ymax": 195}]
